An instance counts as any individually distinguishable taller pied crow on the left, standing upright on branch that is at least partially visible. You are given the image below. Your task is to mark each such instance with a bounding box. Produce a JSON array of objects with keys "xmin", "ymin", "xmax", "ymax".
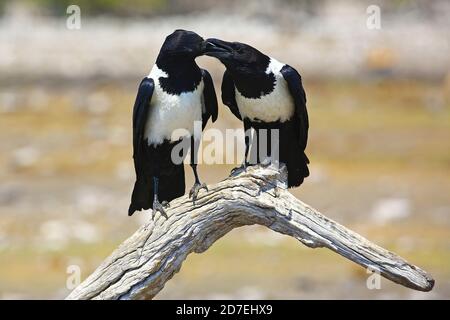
[{"xmin": 128, "ymin": 30, "xmax": 217, "ymax": 217}]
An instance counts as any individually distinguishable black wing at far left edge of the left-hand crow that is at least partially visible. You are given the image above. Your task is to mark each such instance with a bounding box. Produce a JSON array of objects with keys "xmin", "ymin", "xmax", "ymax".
[{"xmin": 133, "ymin": 78, "xmax": 155, "ymax": 176}]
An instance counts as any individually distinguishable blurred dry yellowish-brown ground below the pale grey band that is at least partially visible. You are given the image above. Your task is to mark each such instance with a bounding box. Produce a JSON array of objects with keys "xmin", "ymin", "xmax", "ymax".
[{"xmin": 0, "ymin": 79, "xmax": 450, "ymax": 299}]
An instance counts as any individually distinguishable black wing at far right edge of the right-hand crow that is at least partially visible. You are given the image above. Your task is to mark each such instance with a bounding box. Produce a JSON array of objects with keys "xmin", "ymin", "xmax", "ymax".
[{"xmin": 281, "ymin": 65, "xmax": 309, "ymax": 150}]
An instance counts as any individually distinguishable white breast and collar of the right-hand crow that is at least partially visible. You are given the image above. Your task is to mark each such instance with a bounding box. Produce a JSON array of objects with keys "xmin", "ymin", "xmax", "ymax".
[{"xmin": 235, "ymin": 58, "xmax": 295, "ymax": 122}]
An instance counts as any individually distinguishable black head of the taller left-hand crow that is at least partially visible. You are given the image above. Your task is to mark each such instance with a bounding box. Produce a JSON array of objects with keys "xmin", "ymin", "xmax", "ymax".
[{"xmin": 158, "ymin": 29, "xmax": 204, "ymax": 60}]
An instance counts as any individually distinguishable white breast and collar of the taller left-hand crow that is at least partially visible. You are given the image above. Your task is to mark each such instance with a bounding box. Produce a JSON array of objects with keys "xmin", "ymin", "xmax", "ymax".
[{"xmin": 145, "ymin": 65, "xmax": 204, "ymax": 145}]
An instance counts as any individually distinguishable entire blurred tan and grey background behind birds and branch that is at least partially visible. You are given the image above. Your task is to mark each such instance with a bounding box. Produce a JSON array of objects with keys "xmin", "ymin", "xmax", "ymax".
[{"xmin": 0, "ymin": 0, "xmax": 450, "ymax": 299}]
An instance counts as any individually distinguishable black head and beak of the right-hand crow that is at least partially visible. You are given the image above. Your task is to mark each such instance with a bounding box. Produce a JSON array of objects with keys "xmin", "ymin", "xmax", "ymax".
[{"xmin": 203, "ymin": 38, "xmax": 270, "ymax": 74}]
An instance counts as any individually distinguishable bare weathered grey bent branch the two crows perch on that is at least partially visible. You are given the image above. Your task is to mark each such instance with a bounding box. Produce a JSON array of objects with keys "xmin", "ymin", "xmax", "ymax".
[{"xmin": 67, "ymin": 166, "xmax": 434, "ymax": 299}]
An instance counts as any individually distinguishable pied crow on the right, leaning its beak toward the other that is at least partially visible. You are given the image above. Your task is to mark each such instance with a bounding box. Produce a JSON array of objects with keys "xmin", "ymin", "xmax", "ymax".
[{"xmin": 204, "ymin": 39, "xmax": 309, "ymax": 187}]
